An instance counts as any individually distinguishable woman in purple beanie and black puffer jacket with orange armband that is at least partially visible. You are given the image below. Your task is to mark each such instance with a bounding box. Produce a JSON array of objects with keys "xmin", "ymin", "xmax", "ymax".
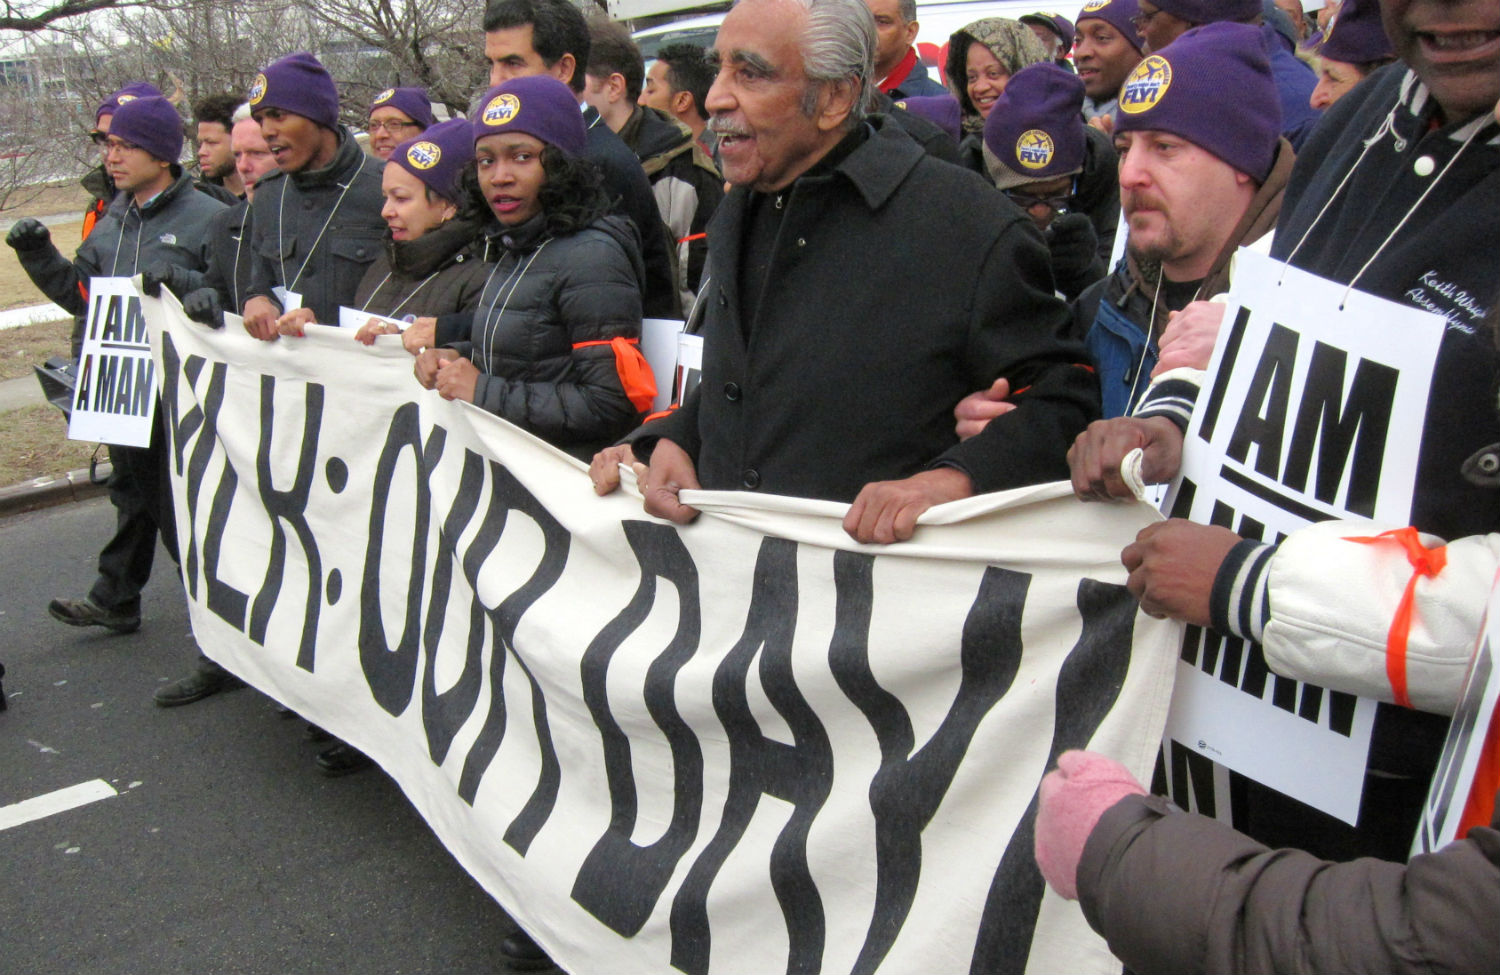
[{"xmin": 416, "ymin": 75, "xmax": 656, "ymax": 456}]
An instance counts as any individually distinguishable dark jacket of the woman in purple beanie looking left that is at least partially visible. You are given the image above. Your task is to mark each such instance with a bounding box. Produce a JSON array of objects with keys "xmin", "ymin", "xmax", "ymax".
[{"xmin": 353, "ymin": 216, "xmax": 489, "ymax": 318}]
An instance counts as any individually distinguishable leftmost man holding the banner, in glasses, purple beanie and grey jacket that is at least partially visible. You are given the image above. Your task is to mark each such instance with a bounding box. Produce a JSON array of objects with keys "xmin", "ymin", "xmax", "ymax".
[{"xmin": 12, "ymin": 96, "xmax": 224, "ymax": 633}]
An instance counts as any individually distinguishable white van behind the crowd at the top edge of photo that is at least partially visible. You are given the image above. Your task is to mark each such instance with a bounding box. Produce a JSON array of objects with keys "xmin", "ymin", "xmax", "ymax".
[{"xmin": 624, "ymin": 0, "xmax": 1083, "ymax": 81}]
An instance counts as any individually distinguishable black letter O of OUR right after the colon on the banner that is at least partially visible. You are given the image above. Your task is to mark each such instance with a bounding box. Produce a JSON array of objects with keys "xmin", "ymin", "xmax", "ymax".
[{"xmin": 359, "ymin": 404, "xmax": 447, "ymax": 716}]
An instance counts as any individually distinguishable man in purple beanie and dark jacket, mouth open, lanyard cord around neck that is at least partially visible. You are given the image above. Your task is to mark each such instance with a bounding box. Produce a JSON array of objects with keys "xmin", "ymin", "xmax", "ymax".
[{"xmin": 245, "ymin": 53, "xmax": 386, "ymax": 342}]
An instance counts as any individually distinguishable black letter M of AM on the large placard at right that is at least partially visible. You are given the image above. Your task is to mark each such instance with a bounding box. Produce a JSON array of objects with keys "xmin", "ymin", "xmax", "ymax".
[{"xmin": 1281, "ymin": 342, "xmax": 1400, "ymax": 518}]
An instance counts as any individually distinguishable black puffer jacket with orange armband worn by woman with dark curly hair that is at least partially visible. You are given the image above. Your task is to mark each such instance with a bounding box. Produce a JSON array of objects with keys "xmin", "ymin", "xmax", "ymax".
[{"xmin": 440, "ymin": 216, "xmax": 645, "ymax": 458}]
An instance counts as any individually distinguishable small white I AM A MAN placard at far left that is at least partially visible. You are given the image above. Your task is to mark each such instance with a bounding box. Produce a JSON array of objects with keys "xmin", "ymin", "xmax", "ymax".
[{"xmin": 68, "ymin": 278, "xmax": 156, "ymax": 447}]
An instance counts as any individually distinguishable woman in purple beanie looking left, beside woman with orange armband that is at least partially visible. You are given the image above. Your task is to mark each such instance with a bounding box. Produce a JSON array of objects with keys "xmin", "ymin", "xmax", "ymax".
[{"xmin": 278, "ymin": 119, "xmax": 489, "ymax": 345}]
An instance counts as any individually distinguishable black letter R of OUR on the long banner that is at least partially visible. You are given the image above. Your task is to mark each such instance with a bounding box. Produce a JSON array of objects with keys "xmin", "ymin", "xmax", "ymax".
[{"xmin": 459, "ymin": 462, "xmax": 572, "ymax": 857}]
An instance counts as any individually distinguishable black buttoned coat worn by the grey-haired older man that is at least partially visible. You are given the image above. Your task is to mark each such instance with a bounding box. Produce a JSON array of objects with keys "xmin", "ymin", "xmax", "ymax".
[{"xmin": 632, "ymin": 116, "xmax": 1100, "ymax": 501}]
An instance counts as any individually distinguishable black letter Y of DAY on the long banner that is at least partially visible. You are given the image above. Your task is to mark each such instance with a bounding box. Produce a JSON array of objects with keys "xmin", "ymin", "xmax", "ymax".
[{"xmin": 828, "ymin": 552, "xmax": 1031, "ymax": 974}]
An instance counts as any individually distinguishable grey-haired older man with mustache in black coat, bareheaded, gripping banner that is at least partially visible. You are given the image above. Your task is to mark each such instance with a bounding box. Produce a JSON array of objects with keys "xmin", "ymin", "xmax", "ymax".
[{"xmin": 590, "ymin": 0, "xmax": 1098, "ymax": 543}]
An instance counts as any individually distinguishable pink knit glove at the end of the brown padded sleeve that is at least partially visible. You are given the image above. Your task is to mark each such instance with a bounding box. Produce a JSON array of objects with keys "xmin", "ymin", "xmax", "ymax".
[{"xmin": 1037, "ymin": 752, "xmax": 1146, "ymax": 900}]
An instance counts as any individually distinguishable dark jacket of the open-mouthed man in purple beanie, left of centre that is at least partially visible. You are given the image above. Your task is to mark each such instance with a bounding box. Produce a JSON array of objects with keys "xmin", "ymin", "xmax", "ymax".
[{"xmin": 240, "ymin": 128, "xmax": 386, "ymax": 324}]
